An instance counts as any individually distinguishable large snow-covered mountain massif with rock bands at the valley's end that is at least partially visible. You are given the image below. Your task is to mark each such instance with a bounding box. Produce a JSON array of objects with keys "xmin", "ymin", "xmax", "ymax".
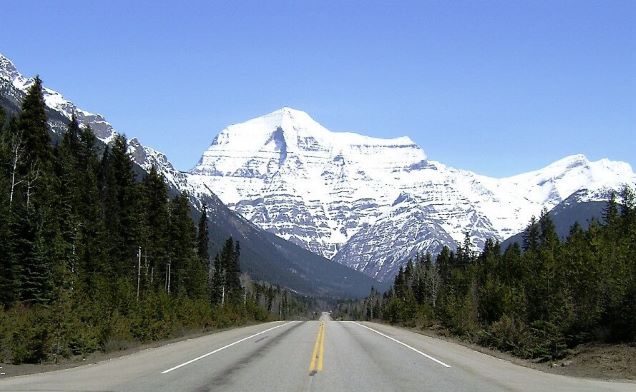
[{"xmin": 188, "ymin": 108, "xmax": 636, "ymax": 280}]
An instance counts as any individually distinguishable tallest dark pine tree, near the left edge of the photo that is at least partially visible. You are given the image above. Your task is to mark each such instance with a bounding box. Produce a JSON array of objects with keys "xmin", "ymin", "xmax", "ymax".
[{"xmin": 8, "ymin": 77, "xmax": 60, "ymax": 303}]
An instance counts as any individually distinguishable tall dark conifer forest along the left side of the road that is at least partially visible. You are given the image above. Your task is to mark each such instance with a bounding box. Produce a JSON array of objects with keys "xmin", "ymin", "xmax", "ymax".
[{"xmin": 0, "ymin": 78, "xmax": 309, "ymax": 363}]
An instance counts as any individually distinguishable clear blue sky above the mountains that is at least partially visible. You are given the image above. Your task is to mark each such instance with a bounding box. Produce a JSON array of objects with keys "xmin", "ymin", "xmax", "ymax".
[{"xmin": 0, "ymin": 0, "xmax": 636, "ymax": 176}]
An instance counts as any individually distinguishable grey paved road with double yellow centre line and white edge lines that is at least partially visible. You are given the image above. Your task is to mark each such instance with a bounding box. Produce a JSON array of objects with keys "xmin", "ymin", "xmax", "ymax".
[{"xmin": 0, "ymin": 313, "xmax": 636, "ymax": 392}]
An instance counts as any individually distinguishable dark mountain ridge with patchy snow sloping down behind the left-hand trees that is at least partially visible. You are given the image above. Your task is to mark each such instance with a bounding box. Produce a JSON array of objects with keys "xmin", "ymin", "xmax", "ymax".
[{"xmin": 0, "ymin": 54, "xmax": 381, "ymax": 297}]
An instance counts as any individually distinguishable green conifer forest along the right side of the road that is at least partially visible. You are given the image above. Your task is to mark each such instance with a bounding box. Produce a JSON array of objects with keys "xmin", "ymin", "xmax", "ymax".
[{"xmin": 338, "ymin": 191, "xmax": 636, "ymax": 360}]
